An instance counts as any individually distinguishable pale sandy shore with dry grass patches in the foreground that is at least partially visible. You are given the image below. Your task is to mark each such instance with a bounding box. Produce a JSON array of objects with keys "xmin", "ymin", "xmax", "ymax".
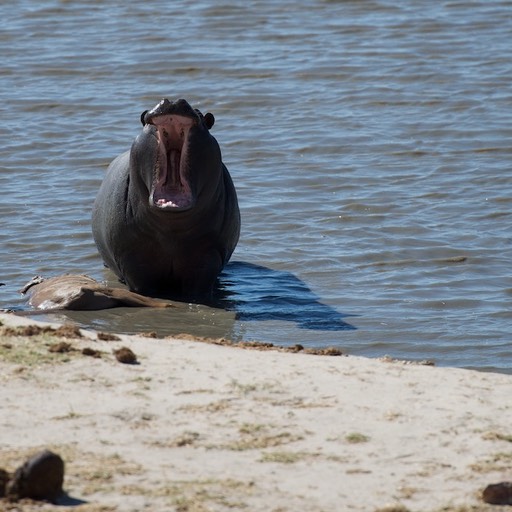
[{"xmin": 0, "ymin": 314, "xmax": 512, "ymax": 512}]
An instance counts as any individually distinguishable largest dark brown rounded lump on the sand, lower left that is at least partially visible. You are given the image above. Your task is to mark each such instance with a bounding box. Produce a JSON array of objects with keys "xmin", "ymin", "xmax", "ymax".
[{"xmin": 6, "ymin": 450, "xmax": 64, "ymax": 501}]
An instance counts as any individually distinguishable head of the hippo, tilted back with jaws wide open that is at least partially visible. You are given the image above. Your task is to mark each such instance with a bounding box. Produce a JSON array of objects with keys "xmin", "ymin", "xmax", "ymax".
[{"xmin": 132, "ymin": 99, "xmax": 222, "ymax": 211}]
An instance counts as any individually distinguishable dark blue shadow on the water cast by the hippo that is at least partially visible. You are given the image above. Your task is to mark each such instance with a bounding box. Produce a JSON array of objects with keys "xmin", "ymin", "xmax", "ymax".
[{"xmin": 213, "ymin": 261, "xmax": 356, "ymax": 331}]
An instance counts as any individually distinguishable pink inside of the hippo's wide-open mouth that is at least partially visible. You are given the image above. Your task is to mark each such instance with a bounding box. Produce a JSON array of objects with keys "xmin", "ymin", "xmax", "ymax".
[{"xmin": 151, "ymin": 115, "xmax": 194, "ymax": 209}]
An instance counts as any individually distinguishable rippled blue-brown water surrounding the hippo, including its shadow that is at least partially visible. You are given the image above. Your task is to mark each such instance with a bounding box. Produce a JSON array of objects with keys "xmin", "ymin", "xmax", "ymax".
[{"xmin": 0, "ymin": 0, "xmax": 512, "ymax": 373}]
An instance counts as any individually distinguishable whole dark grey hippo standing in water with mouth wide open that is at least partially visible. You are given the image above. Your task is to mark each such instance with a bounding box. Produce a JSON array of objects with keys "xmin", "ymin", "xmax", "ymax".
[{"xmin": 92, "ymin": 99, "xmax": 240, "ymax": 300}]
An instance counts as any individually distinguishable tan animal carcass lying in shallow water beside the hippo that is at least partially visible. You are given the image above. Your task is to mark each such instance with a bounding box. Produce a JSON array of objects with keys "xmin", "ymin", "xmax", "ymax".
[{"xmin": 20, "ymin": 274, "xmax": 173, "ymax": 311}]
